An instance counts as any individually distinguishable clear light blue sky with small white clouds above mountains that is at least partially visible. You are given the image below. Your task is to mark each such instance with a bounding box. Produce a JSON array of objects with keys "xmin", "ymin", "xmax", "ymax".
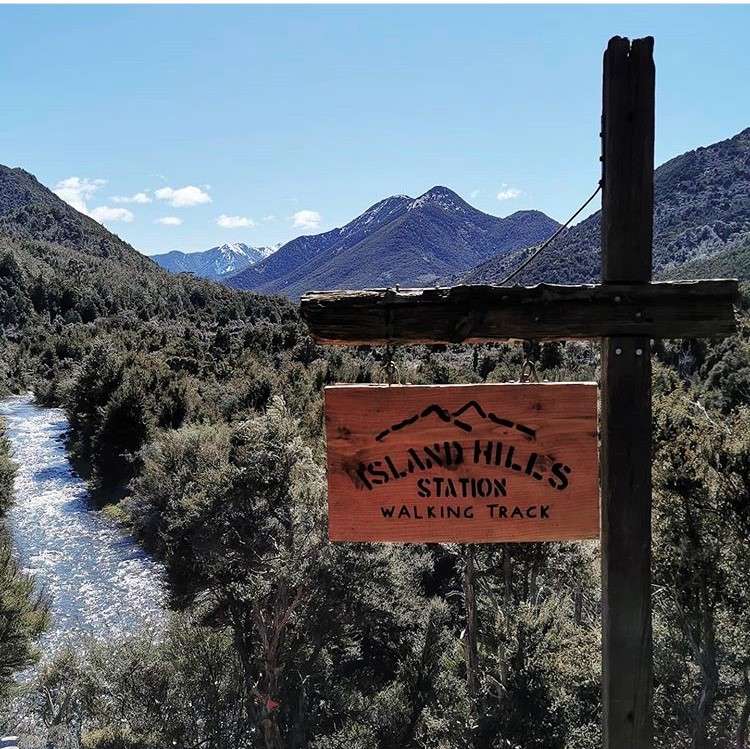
[{"xmin": 0, "ymin": 5, "xmax": 750, "ymax": 253}]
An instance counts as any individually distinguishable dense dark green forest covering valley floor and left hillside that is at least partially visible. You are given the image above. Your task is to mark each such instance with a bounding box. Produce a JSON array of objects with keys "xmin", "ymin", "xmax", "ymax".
[{"xmin": 0, "ymin": 165, "xmax": 750, "ymax": 749}]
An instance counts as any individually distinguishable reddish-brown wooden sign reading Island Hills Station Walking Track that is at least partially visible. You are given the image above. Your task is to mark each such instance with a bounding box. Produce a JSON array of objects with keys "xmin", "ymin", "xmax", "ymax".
[{"xmin": 325, "ymin": 383, "xmax": 599, "ymax": 542}]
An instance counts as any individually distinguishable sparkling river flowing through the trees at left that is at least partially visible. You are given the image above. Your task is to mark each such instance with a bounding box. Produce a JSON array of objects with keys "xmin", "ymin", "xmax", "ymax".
[{"xmin": 0, "ymin": 395, "xmax": 167, "ymax": 656}]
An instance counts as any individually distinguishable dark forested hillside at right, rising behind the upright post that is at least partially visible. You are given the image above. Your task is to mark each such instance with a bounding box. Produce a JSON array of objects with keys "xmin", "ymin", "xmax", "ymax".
[{"xmin": 462, "ymin": 128, "xmax": 750, "ymax": 284}]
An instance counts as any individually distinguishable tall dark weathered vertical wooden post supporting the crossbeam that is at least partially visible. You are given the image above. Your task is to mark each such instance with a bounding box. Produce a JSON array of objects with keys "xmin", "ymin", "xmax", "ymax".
[{"xmin": 600, "ymin": 37, "xmax": 654, "ymax": 749}]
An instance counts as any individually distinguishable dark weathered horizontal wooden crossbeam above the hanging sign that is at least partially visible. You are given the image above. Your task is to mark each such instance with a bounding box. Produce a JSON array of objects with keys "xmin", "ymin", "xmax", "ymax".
[{"xmin": 301, "ymin": 280, "xmax": 738, "ymax": 346}]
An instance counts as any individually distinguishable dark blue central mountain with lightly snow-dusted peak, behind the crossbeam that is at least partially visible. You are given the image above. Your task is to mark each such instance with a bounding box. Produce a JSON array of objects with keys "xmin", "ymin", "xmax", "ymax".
[{"xmin": 226, "ymin": 186, "xmax": 558, "ymax": 298}]
